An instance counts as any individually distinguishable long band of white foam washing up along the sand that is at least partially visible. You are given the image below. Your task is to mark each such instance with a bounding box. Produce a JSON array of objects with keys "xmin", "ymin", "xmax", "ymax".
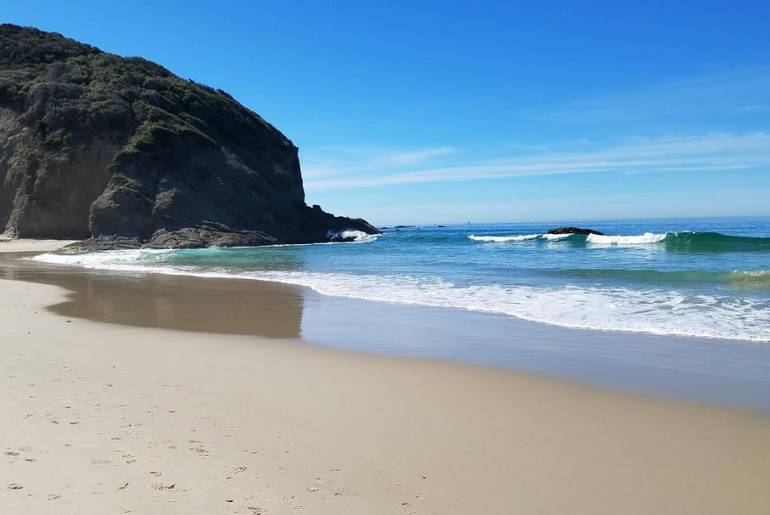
[{"xmin": 32, "ymin": 250, "xmax": 770, "ymax": 342}]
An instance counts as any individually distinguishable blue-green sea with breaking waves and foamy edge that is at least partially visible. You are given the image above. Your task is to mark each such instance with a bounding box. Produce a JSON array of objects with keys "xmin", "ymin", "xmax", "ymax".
[{"xmin": 38, "ymin": 218, "xmax": 770, "ymax": 342}]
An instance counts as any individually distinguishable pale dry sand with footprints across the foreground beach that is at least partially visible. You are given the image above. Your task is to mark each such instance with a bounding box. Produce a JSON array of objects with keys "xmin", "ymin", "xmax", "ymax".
[{"xmin": 0, "ymin": 243, "xmax": 770, "ymax": 515}]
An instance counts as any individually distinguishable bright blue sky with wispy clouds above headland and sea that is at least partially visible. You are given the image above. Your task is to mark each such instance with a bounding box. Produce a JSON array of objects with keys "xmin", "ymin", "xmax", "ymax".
[{"xmin": 0, "ymin": 0, "xmax": 770, "ymax": 225}]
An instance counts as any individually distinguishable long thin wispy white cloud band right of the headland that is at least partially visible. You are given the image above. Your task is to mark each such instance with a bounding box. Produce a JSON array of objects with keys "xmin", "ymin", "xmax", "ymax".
[{"xmin": 304, "ymin": 132, "xmax": 770, "ymax": 191}]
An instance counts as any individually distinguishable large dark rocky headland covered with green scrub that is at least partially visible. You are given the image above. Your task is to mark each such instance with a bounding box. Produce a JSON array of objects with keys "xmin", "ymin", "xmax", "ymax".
[{"xmin": 0, "ymin": 25, "xmax": 377, "ymax": 248}]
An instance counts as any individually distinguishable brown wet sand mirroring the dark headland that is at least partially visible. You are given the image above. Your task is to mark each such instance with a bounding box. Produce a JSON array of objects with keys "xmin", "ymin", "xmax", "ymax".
[{"xmin": 0, "ymin": 252, "xmax": 304, "ymax": 339}]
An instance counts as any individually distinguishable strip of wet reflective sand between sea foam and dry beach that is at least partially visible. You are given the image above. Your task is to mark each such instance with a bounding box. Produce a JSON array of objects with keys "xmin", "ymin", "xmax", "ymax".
[{"xmin": 6, "ymin": 246, "xmax": 770, "ymax": 415}]
